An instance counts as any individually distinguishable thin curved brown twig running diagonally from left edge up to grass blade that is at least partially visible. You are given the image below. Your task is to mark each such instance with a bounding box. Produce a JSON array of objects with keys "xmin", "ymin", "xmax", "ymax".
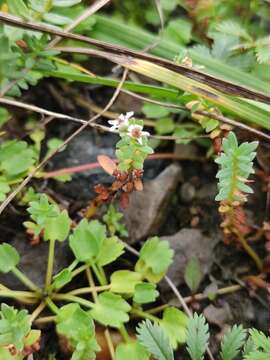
[{"xmin": 0, "ymin": 69, "xmax": 128, "ymax": 214}]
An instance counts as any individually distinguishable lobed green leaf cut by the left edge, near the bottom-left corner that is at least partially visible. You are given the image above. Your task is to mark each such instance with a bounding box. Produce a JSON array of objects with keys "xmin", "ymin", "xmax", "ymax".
[{"xmin": 0, "ymin": 304, "xmax": 31, "ymax": 351}]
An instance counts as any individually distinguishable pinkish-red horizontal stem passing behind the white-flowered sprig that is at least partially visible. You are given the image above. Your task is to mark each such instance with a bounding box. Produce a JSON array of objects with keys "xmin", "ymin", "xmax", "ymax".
[{"xmin": 42, "ymin": 153, "xmax": 201, "ymax": 179}]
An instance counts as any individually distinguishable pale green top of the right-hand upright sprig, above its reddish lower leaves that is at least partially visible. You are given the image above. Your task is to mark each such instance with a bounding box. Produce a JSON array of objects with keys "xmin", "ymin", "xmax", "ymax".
[{"xmin": 215, "ymin": 132, "xmax": 258, "ymax": 202}]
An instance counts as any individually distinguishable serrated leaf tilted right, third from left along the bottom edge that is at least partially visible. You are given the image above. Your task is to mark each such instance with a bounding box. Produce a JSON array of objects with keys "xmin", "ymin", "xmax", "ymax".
[{"xmin": 220, "ymin": 325, "xmax": 246, "ymax": 360}]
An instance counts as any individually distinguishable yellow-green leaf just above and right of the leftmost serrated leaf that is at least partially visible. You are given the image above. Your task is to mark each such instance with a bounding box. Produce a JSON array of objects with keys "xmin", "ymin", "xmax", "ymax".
[{"xmin": 160, "ymin": 307, "xmax": 188, "ymax": 349}]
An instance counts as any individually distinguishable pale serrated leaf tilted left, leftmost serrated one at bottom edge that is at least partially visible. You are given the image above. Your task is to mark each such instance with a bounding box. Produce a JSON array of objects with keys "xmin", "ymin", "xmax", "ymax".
[{"xmin": 136, "ymin": 320, "xmax": 174, "ymax": 360}]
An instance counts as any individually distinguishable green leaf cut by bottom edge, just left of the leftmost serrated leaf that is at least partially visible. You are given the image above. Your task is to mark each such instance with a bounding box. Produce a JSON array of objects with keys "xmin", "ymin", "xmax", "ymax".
[{"xmin": 115, "ymin": 341, "xmax": 149, "ymax": 360}]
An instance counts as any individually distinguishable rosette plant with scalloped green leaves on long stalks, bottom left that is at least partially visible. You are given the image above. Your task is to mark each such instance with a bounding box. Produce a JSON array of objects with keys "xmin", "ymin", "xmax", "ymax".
[{"xmin": 0, "ymin": 194, "xmax": 190, "ymax": 360}]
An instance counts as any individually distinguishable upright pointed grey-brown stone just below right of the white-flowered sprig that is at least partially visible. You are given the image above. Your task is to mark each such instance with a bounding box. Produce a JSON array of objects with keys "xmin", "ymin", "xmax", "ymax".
[{"xmin": 124, "ymin": 164, "xmax": 182, "ymax": 244}]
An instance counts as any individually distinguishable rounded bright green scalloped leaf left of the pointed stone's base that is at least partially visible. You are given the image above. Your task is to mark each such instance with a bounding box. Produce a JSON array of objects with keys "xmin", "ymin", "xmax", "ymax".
[{"xmin": 69, "ymin": 219, "xmax": 106, "ymax": 262}]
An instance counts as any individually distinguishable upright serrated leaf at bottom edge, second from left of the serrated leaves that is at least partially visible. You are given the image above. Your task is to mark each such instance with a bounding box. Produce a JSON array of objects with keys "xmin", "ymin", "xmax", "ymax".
[{"xmin": 187, "ymin": 313, "xmax": 209, "ymax": 360}]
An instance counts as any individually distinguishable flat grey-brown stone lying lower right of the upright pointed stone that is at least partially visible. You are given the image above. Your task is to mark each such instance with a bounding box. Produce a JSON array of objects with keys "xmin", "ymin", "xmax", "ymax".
[{"xmin": 160, "ymin": 228, "xmax": 219, "ymax": 291}]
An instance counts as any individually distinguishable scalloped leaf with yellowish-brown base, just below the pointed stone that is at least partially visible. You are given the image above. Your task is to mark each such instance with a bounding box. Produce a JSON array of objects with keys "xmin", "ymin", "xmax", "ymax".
[{"xmin": 135, "ymin": 236, "xmax": 173, "ymax": 282}]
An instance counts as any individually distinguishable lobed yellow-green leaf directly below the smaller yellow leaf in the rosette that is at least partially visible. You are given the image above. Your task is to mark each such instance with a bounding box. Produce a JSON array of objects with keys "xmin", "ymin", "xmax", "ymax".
[{"xmin": 90, "ymin": 292, "xmax": 130, "ymax": 328}]
